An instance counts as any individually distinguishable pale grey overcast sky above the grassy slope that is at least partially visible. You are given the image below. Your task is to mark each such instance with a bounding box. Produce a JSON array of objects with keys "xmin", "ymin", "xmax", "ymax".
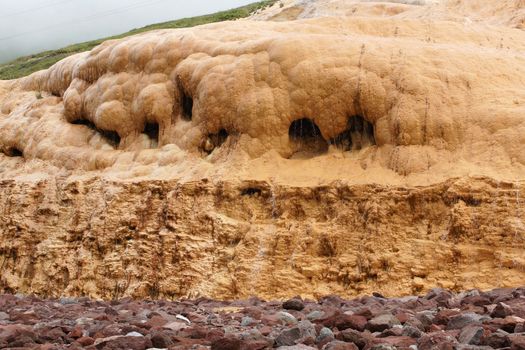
[{"xmin": 0, "ymin": 0, "xmax": 256, "ymax": 63}]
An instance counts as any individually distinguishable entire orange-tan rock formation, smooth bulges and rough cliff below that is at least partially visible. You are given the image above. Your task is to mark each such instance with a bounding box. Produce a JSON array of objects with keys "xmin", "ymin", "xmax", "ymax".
[{"xmin": 0, "ymin": 1, "xmax": 525, "ymax": 298}]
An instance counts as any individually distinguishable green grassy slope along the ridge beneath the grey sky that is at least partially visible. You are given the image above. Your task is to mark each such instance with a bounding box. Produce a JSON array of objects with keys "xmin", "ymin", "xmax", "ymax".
[{"xmin": 0, "ymin": 0, "xmax": 277, "ymax": 80}]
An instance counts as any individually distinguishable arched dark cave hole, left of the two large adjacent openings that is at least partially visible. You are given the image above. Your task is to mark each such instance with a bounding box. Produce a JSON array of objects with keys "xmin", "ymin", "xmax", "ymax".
[{"xmin": 288, "ymin": 118, "xmax": 328, "ymax": 153}]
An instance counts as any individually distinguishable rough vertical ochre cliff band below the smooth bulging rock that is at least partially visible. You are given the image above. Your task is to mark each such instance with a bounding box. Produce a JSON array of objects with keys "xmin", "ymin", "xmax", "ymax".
[{"xmin": 0, "ymin": 178, "xmax": 525, "ymax": 299}]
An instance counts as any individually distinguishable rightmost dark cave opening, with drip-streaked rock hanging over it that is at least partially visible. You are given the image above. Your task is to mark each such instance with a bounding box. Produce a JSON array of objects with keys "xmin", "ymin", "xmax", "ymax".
[{"xmin": 330, "ymin": 115, "xmax": 376, "ymax": 151}]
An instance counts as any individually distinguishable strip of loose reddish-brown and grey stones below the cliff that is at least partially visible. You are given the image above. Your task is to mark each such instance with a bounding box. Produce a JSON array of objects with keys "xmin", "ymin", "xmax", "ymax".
[{"xmin": 0, "ymin": 287, "xmax": 525, "ymax": 350}]
